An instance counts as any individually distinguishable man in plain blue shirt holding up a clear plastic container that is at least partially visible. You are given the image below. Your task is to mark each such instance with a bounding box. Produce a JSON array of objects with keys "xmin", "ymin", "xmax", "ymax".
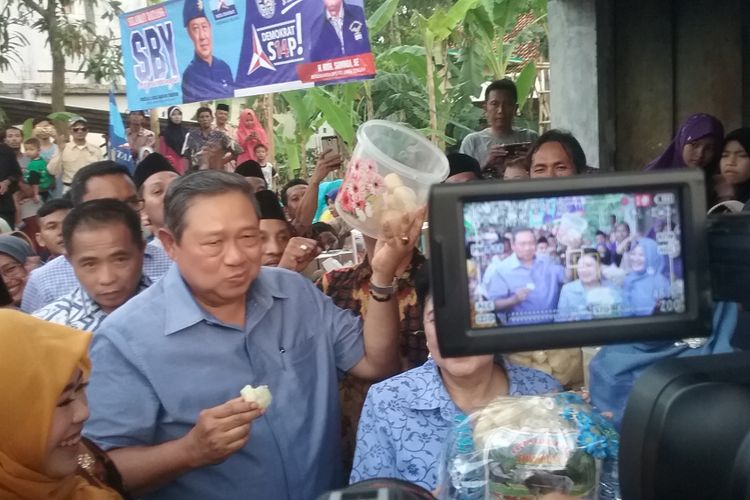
[{"xmin": 85, "ymin": 171, "xmax": 423, "ymax": 500}]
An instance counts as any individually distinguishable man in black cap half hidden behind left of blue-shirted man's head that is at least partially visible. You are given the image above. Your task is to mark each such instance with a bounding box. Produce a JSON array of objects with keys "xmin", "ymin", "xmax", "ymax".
[{"xmin": 133, "ymin": 153, "xmax": 180, "ymax": 248}]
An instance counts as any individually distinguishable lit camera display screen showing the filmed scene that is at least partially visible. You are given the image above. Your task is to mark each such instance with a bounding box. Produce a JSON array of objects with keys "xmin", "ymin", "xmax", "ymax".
[{"xmin": 464, "ymin": 190, "xmax": 685, "ymax": 328}]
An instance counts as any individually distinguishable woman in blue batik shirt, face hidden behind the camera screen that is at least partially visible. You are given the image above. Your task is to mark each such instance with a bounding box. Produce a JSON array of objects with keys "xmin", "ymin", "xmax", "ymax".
[{"xmin": 351, "ymin": 266, "xmax": 561, "ymax": 490}]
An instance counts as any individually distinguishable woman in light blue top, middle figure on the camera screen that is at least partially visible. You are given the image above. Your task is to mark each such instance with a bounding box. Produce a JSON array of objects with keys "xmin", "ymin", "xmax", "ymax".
[{"xmin": 555, "ymin": 248, "xmax": 622, "ymax": 322}]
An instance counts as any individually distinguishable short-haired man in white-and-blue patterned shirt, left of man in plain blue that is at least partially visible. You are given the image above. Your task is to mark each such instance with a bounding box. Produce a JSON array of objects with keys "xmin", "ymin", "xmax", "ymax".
[{"xmin": 34, "ymin": 199, "xmax": 151, "ymax": 332}]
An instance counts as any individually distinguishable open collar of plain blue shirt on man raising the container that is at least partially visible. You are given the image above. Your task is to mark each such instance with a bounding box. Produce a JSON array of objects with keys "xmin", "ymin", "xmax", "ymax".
[{"xmin": 161, "ymin": 264, "xmax": 288, "ymax": 335}]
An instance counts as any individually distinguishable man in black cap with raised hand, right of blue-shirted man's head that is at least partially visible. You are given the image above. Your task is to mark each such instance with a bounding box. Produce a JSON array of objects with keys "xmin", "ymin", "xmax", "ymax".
[{"xmin": 255, "ymin": 189, "xmax": 320, "ymax": 272}]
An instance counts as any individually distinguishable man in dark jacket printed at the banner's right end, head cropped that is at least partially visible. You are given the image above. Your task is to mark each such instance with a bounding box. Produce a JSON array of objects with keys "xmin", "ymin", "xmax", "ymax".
[{"xmin": 309, "ymin": 0, "xmax": 370, "ymax": 62}]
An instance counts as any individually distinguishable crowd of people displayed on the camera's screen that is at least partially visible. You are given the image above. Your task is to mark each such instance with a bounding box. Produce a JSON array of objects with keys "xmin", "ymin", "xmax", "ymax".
[{"xmin": 467, "ymin": 215, "xmax": 682, "ymax": 326}]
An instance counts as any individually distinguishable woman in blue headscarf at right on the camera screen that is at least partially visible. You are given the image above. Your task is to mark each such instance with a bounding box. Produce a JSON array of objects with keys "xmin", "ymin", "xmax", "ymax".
[{"xmin": 622, "ymin": 238, "xmax": 671, "ymax": 316}]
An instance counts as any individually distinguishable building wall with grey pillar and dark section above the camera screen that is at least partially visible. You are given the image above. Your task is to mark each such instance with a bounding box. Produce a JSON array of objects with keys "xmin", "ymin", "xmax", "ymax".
[{"xmin": 549, "ymin": 0, "xmax": 750, "ymax": 170}]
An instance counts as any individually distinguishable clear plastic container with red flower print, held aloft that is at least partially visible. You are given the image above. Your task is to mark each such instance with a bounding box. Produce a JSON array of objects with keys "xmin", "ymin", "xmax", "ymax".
[{"xmin": 336, "ymin": 120, "xmax": 449, "ymax": 238}]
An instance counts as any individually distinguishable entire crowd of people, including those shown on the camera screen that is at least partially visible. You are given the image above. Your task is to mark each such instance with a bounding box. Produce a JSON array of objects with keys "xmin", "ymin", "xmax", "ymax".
[{"xmin": 0, "ymin": 76, "xmax": 750, "ymax": 499}]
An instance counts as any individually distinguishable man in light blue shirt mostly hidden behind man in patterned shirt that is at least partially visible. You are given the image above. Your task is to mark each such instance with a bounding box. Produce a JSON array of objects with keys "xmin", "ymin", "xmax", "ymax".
[{"xmin": 21, "ymin": 161, "xmax": 172, "ymax": 313}]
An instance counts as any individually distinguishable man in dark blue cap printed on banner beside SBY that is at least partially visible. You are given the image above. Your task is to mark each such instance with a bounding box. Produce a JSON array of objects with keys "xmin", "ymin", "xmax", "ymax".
[{"xmin": 182, "ymin": 0, "xmax": 234, "ymax": 102}]
